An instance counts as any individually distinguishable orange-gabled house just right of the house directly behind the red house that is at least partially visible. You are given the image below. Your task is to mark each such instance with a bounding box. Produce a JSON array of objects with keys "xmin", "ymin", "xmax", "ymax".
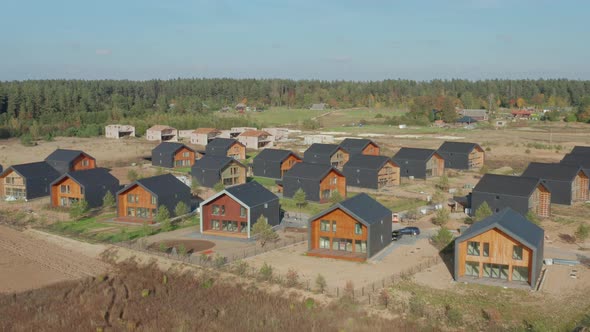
[{"xmin": 252, "ymin": 149, "xmax": 302, "ymax": 179}]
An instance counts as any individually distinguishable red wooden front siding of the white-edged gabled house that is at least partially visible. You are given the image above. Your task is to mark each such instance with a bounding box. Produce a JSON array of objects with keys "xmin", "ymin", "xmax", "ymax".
[{"xmin": 202, "ymin": 194, "xmax": 248, "ymax": 238}]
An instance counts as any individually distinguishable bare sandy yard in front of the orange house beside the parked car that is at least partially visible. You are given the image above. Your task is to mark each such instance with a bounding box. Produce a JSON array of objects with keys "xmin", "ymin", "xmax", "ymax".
[{"xmin": 246, "ymin": 239, "xmax": 437, "ymax": 289}]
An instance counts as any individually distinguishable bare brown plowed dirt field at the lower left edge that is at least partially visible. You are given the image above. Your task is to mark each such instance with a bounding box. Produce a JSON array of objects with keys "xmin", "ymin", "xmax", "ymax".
[{"xmin": 0, "ymin": 226, "xmax": 108, "ymax": 293}]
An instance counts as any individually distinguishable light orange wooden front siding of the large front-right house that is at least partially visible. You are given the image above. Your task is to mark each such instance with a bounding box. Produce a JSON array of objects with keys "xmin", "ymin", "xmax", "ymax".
[{"xmin": 457, "ymin": 228, "xmax": 533, "ymax": 285}]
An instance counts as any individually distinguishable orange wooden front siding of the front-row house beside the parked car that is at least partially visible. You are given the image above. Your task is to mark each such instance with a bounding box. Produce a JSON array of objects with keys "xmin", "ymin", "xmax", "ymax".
[{"xmin": 310, "ymin": 209, "xmax": 368, "ymax": 260}]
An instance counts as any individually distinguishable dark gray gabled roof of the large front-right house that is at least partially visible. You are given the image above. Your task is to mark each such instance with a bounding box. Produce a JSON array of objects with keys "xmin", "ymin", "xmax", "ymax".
[{"xmin": 455, "ymin": 207, "xmax": 545, "ymax": 250}]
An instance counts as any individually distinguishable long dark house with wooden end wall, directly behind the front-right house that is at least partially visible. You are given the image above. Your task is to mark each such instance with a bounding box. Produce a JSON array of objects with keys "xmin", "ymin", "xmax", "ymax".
[{"xmin": 471, "ymin": 174, "xmax": 551, "ymax": 217}]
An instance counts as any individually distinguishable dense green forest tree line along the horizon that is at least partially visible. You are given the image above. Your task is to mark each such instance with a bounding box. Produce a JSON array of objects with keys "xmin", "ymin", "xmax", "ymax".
[{"xmin": 0, "ymin": 79, "xmax": 590, "ymax": 137}]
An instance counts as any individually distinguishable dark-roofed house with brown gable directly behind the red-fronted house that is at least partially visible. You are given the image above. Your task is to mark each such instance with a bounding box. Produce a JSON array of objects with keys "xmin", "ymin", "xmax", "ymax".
[{"xmin": 191, "ymin": 154, "xmax": 246, "ymax": 188}]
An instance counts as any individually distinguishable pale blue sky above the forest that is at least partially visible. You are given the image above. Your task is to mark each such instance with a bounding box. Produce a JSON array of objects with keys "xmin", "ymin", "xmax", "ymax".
[{"xmin": 0, "ymin": 0, "xmax": 590, "ymax": 80}]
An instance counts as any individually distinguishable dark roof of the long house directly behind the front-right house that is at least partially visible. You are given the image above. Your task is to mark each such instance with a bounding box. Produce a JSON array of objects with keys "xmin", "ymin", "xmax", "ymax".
[{"xmin": 473, "ymin": 174, "xmax": 549, "ymax": 197}]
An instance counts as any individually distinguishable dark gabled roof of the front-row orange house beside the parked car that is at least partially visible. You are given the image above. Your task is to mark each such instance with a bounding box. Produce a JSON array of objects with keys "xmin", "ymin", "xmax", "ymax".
[{"xmin": 309, "ymin": 193, "xmax": 391, "ymax": 225}]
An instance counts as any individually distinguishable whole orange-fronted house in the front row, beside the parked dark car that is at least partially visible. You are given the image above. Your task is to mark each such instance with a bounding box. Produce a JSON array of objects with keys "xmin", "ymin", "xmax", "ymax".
[{"xmin": 307, "ymin": 193, "xmax": 392, "ymax": 261}]
